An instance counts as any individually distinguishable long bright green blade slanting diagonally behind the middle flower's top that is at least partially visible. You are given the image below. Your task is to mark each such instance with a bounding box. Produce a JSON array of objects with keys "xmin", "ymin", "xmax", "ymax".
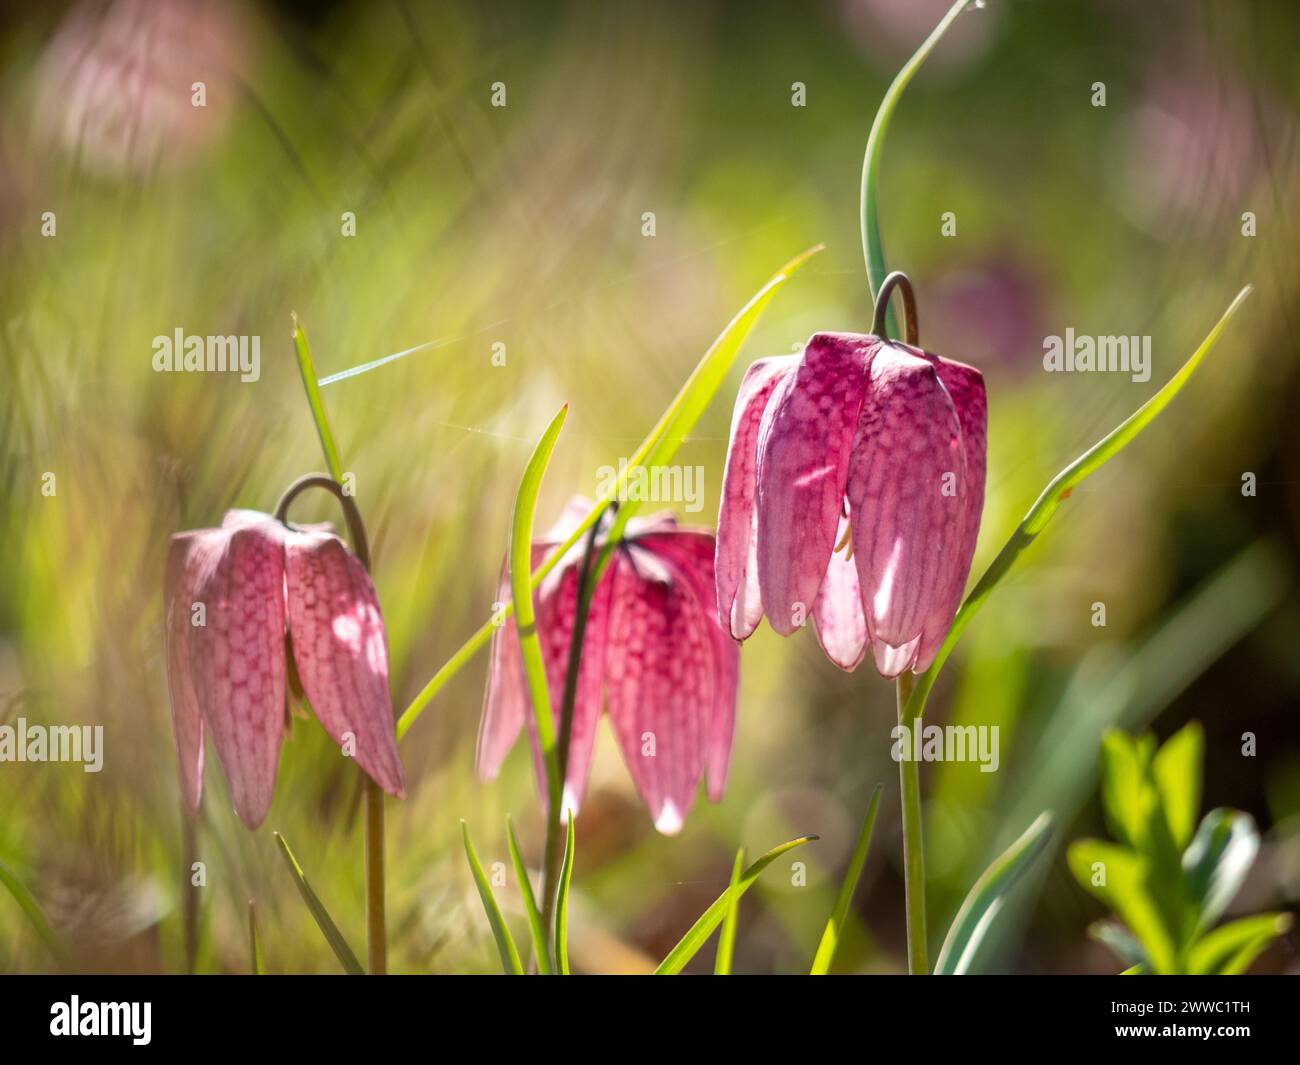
[{"xmin": 398, "ymin": 244, "xmax": 822, "ymax": 740}]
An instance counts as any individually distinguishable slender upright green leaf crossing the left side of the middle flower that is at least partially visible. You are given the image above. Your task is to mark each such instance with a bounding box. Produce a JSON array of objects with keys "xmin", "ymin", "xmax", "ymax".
[{"xmin": 510, "ymin": 403, "xmax": 568, "ymax": 809}]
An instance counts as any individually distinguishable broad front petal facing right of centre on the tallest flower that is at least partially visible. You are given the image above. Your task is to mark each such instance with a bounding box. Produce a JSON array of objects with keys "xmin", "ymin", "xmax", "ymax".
[{"xmin": 848, "ymin": 345, "xmax": 969, "ymax": 676}]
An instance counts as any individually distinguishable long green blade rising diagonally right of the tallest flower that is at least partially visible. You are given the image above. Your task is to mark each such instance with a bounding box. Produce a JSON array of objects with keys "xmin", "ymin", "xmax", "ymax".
[{"xmin": 907, "ymin": 285, "xmax": 1251, "ymax": 719}]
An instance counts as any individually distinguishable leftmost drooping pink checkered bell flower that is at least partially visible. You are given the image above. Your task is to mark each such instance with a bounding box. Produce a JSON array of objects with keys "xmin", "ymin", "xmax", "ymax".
[{"xmin": 164, "ymin": 510, "xmax": 406, "ymax": 828}]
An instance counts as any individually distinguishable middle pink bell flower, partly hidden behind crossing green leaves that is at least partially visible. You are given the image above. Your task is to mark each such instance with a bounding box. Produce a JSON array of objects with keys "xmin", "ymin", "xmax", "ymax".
[{"xmin": 476, "ymin": 498, "xmax": 740, "ymax": 835}]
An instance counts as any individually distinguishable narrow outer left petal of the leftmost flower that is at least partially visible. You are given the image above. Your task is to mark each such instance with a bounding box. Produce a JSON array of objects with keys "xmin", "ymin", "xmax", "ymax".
[{"xmin": 163, "ymin": 529, "xmax": 213, "ymax": 813}]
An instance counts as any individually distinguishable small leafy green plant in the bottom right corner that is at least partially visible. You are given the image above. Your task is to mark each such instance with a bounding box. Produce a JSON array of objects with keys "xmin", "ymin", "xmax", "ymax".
[{"xmin": 1069, "ymin": 722, "xmax": 1291, "ymax": 975}]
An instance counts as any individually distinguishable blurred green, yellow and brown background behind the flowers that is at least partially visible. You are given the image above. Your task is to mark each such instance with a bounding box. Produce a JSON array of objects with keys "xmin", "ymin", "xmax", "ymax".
[{"xmin": 0, "ymin": 0, "xmax": 1300, "ymax": 973}]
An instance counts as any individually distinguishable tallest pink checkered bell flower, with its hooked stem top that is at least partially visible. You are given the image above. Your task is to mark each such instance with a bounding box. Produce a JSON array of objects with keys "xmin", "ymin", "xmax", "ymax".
[{"xmin": 716, "ymin": 274, "xmax": 987, "ymax": 677}]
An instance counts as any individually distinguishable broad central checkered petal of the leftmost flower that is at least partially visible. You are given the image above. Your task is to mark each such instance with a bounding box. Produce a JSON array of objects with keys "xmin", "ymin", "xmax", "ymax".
[{"xmin": 187, "ymin": 521, "xmax": 285, "ymax": 828}]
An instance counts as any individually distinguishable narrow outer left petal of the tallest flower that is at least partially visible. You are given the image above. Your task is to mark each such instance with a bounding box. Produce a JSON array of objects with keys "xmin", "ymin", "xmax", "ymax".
[{"xmin": 715, "ymin": 355, "xmax": 798, "ymax": 640}]
